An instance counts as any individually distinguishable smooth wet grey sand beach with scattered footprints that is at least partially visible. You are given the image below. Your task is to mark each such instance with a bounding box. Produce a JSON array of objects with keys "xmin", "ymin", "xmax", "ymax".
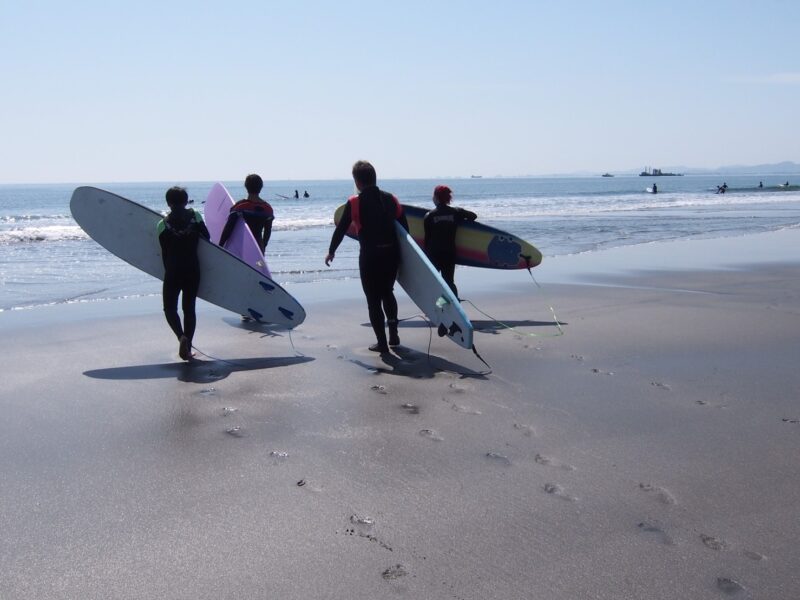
[{"xmin": 0, "ymin": 231, "xmax": 800, "ymax": 600}]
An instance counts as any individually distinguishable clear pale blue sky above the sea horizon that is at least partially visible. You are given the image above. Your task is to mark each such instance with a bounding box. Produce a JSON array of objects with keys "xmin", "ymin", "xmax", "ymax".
[{"xmin": 0, "ymin": 0, "xmax": 800, "ymax": 182}]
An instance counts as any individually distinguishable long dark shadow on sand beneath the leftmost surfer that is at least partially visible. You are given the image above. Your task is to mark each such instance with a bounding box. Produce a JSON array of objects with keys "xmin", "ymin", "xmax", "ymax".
[{"xmin": 83, "ymin": 356, "xmax": 314, "ymax": 383}]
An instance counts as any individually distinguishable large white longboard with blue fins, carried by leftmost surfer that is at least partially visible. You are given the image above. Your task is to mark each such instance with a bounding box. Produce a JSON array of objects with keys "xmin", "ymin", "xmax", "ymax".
[{"xmin": 70, "ymin": 187, "xmax": 306, "ymax": 329}]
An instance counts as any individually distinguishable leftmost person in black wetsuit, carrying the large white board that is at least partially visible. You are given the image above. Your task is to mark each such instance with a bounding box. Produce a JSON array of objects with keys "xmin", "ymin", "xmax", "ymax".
[{"xmin": 157, "ymin": 187, "xmax": 210, "ymax": 360}]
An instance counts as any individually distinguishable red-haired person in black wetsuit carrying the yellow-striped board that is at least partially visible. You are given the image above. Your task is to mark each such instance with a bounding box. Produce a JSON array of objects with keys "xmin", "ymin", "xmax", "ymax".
[{"xmin": 423, "ymin": 185, "xmax": 478, "ymax": 298}]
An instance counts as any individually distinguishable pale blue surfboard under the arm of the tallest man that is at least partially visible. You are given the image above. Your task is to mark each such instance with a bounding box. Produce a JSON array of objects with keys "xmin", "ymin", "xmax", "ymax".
[{"xmin": 395, "ymin": 221, "xmax": 473, "ymax": 348}]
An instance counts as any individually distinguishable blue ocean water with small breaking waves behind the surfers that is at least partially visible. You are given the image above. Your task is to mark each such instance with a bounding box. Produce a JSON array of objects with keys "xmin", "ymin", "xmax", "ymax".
[{"xmin": 0, "ymin": 175, "xmax": 800, "ymax": 311}]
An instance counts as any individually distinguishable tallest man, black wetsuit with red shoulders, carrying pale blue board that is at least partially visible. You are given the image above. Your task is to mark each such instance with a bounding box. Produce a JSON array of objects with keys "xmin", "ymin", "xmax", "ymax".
[{"xmin": 325, "ymin": 160, "xmax": 408, "ymax": 354}]
